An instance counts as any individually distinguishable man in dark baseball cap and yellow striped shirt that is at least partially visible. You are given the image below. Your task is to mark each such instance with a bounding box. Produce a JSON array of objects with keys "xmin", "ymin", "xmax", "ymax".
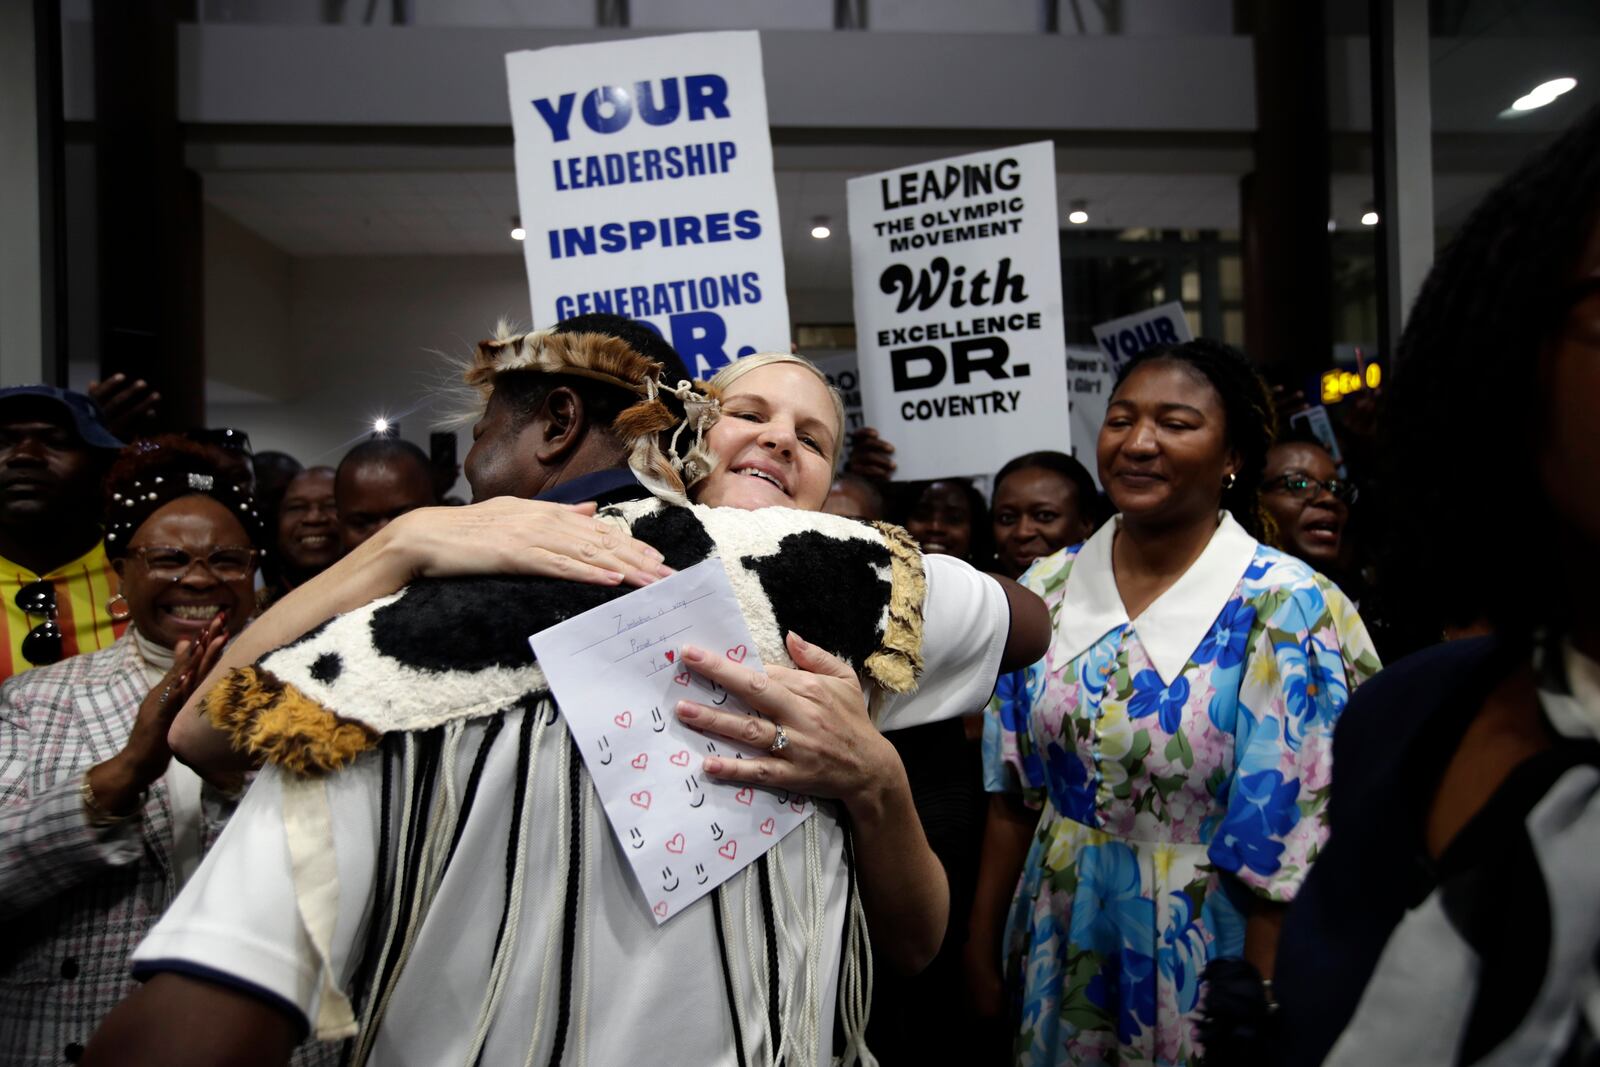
[{"xmin": 0, "ymin": 386, "xmax": 128, "ymax": 681}]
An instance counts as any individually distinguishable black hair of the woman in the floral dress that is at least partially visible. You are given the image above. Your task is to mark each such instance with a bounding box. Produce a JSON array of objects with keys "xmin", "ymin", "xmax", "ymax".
[{"xmin": 1112, "ymin": 338, "xmax": 1278, "ymax": 544}]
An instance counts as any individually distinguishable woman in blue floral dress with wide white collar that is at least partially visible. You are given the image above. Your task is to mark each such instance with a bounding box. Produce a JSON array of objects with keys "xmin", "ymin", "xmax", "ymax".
[{"xmin": 973, "ymin": 341, "xmax": 1378, "ymax": 1065}]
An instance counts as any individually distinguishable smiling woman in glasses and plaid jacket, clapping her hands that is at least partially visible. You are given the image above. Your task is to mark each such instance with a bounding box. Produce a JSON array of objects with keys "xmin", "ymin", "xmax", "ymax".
[{"xmin": 0, "ymin": 437, "xmax": 294, "ymax": 1067}]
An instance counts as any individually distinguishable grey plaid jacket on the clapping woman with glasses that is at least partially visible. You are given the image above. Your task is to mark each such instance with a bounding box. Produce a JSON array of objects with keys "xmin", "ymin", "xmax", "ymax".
[{"xmin": 0, "ymin": 633, "xmax": 232, "ymax": 1067}]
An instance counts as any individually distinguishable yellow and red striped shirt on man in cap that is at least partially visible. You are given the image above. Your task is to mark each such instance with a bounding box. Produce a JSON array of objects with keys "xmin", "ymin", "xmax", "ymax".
[{"xmin": 0, "ymin": 542, "xmax": 128, "ymax": 681}]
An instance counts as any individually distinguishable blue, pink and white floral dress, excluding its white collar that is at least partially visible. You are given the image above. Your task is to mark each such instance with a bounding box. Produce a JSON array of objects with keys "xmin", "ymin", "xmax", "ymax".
[{"xmin": 984, "ymin": 528, "xmax": 1379, "ymax": 1067}]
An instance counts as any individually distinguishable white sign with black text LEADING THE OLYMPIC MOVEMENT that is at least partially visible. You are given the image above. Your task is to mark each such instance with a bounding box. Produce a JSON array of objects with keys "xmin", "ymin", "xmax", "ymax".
[{"xmin": 848, "ymin": 141, "xmax": 1072, "ymax": 480}]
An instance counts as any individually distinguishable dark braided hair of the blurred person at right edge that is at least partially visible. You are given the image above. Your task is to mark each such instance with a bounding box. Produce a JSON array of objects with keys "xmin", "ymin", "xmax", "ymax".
[{"xmin": 1379, "ymin": 107, "xmax": 1600, "ymax": 637}]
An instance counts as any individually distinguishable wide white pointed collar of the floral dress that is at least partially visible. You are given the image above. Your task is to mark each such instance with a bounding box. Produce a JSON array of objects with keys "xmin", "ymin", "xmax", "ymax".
[{"xmin": 1053, "ymin": 512, "xmax": 1258, "ymax": 685}]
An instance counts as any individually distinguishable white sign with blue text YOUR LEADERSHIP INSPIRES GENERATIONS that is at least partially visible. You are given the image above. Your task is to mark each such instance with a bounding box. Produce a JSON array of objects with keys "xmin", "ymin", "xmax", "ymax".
[{"xmin": 506, "ymin": 32, "xmax": 789, "ymax": 376}]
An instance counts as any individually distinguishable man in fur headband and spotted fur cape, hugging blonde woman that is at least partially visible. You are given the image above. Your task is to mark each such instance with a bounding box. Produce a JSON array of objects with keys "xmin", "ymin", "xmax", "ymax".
[{"xmin": 85, "ymin": 321, "xmax": 1048, "ymax": 1067}]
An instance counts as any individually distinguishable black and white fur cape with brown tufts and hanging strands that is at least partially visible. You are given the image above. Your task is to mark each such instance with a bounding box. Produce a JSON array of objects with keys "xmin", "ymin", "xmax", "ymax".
[{"xmin": 205, "ymin": 499, "xmax": 925, "ymax": 1064}]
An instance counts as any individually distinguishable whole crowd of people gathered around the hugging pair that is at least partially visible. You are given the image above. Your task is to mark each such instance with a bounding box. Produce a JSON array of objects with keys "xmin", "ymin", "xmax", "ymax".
[{"xmin": 0, "ymin": 102, "xmax": 1600, "ymax": 1067}]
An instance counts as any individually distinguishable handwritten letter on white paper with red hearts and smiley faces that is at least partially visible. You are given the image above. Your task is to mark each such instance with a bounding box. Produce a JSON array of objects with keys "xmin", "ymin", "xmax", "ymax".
[{"xmin": 528, "ymin": 560, "xmax": 814, "ymax": 923}]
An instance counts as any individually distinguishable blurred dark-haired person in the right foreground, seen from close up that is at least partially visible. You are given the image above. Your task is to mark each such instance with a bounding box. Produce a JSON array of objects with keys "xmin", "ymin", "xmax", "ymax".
[{"xmin": 1228, "ymin": 109, "xmax": 1600, "ymax": 1067}]
